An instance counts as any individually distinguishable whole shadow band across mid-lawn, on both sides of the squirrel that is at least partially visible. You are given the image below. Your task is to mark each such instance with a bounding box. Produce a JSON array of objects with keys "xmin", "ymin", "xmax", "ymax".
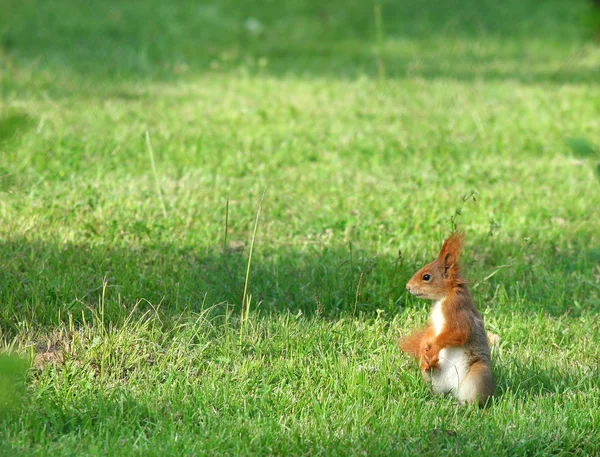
[{"xmin": 0, "ymin": 230, "xmax": 600, "ymax": 333}]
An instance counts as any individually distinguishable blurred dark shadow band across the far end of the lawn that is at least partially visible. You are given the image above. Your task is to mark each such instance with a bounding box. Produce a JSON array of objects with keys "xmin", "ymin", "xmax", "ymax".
[{"xmin": 0, "ymin": 0, "xmax": 600, "ymax": 92}]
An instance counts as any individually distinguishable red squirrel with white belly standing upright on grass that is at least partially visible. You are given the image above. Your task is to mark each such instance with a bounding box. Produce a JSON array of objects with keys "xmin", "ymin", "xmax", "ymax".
[{"xmin": 399, "ymin": 233, "xmax": 494, "ymax": 406}]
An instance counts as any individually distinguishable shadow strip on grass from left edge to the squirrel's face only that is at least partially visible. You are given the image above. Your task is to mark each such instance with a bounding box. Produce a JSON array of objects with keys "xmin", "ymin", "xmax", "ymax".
[{"xmin": 0, "ymin": 240, "xmax": 407, "ymax": 331}]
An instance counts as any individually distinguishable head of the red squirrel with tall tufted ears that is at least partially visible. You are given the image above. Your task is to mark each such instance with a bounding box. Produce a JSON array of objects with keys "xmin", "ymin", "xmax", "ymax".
[{"xmin": 406, "ymin": 233, "xmax": 464, "ymax": 300}]
